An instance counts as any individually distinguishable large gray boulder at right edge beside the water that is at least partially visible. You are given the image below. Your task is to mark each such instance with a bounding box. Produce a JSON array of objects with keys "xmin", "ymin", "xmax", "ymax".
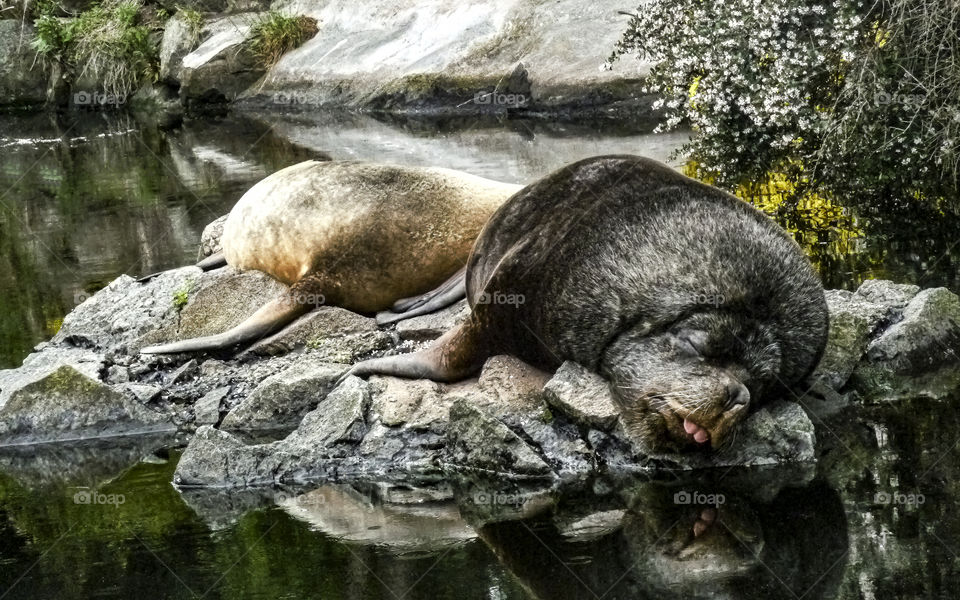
[{"xmin": 853, "ymin": 288, "xmax": 960, "ymax": 398}]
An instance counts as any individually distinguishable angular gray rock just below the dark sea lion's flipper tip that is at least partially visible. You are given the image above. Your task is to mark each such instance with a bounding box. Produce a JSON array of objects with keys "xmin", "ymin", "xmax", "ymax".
[{"xmin": 287, "ymin": 377, "xmax": 370, "ymax": 447}]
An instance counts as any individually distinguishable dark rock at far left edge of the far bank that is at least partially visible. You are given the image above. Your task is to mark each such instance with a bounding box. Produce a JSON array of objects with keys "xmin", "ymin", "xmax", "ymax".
[{"xmin": 0, "ymin": 19, "xmax": 49, "ymax": 107}]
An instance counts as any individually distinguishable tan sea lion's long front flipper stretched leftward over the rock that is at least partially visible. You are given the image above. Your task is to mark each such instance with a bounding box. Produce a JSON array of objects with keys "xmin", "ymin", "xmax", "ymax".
[{"xmin": 140, "ymin": 294, "xmax": 311, "ymax": 354}]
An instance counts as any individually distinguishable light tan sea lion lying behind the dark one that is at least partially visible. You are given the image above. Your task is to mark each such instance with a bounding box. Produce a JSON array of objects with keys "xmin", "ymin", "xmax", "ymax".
[{"xmin": 142, "ymin": 161, "xmax": 521, "ymax": 354}]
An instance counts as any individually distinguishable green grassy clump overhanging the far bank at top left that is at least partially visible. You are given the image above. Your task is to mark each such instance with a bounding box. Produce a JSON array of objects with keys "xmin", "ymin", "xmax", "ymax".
[{"xmin": 33, "ymin": 0, "xmax": 160, "ymax": 96}]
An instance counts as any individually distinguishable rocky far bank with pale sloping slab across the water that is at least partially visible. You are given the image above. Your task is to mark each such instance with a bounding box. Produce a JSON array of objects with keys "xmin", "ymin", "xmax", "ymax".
[{"xmin": 0, "ymin": 0, "xmax": 654, "ymax": 119}]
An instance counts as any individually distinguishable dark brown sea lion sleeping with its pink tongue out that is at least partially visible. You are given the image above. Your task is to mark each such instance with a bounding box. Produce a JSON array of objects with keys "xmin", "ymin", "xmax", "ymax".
[{"xmin": 351, "ymin": 156, "xmax": 827, "ymax": 451}]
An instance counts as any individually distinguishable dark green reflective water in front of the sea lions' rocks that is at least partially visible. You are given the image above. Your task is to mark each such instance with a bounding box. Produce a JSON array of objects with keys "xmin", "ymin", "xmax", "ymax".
[{"xmin": 0, "ymin": 400, "xmax": 960, "ymax": 600}]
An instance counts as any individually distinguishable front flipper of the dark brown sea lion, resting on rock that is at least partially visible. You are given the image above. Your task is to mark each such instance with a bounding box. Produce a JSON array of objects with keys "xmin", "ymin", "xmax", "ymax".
[{"xmin": 341, "ymin": 318, "xmax": 490, "ymax": 382}]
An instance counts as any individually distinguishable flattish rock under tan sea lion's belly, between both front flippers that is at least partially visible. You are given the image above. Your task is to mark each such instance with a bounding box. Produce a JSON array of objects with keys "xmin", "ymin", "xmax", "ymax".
[{"xmin": 247, "ymin": 306, "xmax": 393, "ymax": 363}]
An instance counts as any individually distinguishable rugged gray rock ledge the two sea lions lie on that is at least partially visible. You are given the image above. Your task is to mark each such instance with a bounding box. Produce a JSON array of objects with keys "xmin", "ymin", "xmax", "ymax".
[{"xmin": 0, "ymin": 248, "xmax": 960, "ymax": 487}]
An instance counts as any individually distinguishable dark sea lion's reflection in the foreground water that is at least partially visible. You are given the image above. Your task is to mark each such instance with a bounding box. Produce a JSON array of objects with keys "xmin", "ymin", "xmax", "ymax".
[{"xmin": 468, "ymin": 483, "xmax": 847, "ymax": 600}]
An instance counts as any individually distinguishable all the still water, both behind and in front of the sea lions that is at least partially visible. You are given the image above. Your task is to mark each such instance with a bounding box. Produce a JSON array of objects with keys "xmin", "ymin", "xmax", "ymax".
[{"xmin": 0, "ymin": 113, "xmax": 960, "ymax": 600}]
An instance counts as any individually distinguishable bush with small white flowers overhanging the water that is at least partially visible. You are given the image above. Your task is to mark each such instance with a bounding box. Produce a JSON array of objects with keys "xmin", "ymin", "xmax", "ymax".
[{"xmin": 609, "ymin": 0, "xmax": 960, "ymax": 198}]
